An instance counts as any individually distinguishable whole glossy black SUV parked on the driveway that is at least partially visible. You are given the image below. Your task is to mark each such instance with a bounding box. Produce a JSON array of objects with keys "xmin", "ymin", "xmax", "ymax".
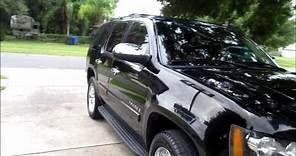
[{"xmin": 87, "ymin": 15, "xmax": 296, "ymax": 156}]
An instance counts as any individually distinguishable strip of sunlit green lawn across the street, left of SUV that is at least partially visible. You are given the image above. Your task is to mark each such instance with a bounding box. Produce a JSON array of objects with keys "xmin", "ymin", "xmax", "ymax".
[{"xmin": 1, "ymin": 39, "xmax": 88, "ymax": 56}]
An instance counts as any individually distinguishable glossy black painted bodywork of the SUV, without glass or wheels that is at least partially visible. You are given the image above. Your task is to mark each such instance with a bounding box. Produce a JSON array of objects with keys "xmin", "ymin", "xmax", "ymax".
[{"xmin": 87, "ymin": 16, "xmax": 296, "ymax": 156}]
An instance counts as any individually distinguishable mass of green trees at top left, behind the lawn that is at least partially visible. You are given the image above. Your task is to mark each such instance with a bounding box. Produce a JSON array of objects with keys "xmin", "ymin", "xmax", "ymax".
[{"xmin": 0, "ymin": 0, "xmax": 117, "ymax": 35}]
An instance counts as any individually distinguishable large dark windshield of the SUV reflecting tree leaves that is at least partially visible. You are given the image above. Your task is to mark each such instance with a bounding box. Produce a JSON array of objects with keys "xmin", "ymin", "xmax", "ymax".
[{"xmin": 156, "ymin": 20, "xmax": 276, "ymax": 66}]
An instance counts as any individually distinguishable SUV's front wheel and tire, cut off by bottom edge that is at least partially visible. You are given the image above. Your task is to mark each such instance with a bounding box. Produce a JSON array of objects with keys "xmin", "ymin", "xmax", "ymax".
[{"xmin": 149, "ymin": 130, "xmax": 198, "ymax": 156}]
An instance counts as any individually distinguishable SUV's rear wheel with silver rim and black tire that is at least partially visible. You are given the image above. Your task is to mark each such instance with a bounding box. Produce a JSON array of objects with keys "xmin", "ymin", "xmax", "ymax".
[{"xmin": 87, "ymin": 77, "xmax": 103, "ymax": 120}]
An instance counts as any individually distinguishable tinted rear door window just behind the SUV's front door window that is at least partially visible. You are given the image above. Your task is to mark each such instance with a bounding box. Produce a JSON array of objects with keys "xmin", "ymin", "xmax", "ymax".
[{"xmin": 107, "ymin": 22, "xmax": 128, "ymax": 52}]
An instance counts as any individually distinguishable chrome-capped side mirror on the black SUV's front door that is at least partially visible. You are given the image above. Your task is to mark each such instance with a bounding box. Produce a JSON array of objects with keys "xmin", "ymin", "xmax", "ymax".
[{"xmin": 113, "ymin": 43, "xmax": 151, "ymax": 66}]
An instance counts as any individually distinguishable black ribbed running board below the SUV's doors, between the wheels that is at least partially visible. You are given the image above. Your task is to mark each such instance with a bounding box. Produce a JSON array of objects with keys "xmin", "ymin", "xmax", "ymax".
[{"xmin": 98, "ymin": 106, "xmax": 148, "ymax": 156}]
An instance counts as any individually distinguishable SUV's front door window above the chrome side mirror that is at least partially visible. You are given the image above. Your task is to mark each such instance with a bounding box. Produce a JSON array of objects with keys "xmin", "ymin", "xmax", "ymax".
[{"xmin": 124, "ymin": 22, "xmax": 148, "ymax": 54}]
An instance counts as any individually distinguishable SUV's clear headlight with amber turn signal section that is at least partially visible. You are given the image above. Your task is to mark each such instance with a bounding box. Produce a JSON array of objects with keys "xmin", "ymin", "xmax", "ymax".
[{"xmin": 229, "ymin": 126, "xmax": 296, "ymax": 156}]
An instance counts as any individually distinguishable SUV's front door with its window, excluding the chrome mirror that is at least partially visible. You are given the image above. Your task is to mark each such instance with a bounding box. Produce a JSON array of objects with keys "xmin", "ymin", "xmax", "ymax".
[{"xmin": 109, "ymin": 22, "xmax": 150, "ymax": 133}]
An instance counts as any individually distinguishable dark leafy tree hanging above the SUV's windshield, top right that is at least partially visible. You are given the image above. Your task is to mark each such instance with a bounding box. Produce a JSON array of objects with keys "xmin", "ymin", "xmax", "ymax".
[{"xmin": 159, "ymin": 0, "xmax": 295, "ymax": 48}]
